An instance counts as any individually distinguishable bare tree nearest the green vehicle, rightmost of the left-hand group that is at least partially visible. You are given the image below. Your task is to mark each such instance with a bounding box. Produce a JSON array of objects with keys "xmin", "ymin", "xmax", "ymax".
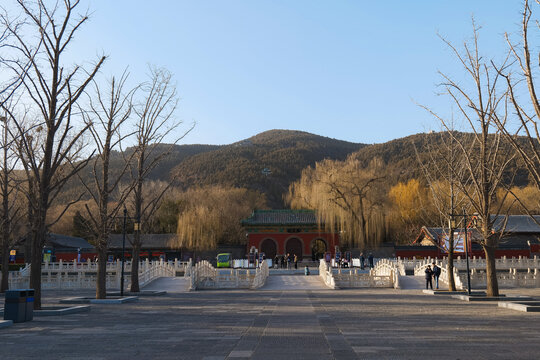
[{"xmin": 130, "ymin": 67, "xmax": 193, "ymax": 292}]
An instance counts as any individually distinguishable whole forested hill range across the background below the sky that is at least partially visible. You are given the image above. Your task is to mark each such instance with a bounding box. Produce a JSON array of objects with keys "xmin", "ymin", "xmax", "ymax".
[{"xmin": 58, "ymin": 130, "xmax": 528, "ymax": 208}]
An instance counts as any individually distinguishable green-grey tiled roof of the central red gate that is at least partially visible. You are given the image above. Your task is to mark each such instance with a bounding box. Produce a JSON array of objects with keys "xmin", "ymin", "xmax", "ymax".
[{"xmin": 242, "ymin": 210, "xmax": 317, "ymax": 226}]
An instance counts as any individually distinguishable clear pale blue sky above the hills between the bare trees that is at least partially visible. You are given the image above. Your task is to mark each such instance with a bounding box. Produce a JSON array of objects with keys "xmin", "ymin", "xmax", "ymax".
[{"xmin": 23, "ymin": 0, "xmax": 522, "ymax": 144}]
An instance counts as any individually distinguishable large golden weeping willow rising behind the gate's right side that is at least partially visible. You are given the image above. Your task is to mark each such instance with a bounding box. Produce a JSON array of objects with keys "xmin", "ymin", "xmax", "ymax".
[{"xmin": 287, "ymin": 156, "xmax": 386, "ymax": 248}]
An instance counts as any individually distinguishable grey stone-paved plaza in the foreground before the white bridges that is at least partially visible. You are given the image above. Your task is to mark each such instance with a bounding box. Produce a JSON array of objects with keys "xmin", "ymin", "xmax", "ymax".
[{"xmin": 0, "ymin": 277, "xmax": 540, "ymax": 360}]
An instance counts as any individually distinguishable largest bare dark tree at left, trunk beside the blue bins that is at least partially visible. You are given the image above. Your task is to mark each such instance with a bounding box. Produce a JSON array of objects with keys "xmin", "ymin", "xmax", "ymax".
[{"xmin": 1, "ymin": 0, "xmax": 105, "ymax": 309}]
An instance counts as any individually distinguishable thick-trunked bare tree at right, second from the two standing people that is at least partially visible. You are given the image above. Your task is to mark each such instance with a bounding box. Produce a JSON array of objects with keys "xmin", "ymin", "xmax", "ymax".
[{"xmin": 430, "ymin": 24, "xmax": 514, "ymax": 296}]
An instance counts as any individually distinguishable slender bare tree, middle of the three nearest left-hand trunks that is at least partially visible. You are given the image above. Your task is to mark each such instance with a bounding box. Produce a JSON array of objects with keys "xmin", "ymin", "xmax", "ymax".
[{"xmin": 79, "ymin": 72, "xmax": 136, "ymax": 299}]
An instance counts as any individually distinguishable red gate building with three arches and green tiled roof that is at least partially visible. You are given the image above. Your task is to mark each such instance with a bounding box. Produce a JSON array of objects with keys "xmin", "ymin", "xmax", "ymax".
[{"xmin": 242, "ymin": 210, "xmax": 339, "ymax": 260}]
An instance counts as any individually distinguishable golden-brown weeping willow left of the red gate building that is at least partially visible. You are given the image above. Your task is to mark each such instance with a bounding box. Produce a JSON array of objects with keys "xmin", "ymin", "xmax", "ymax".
[{"xmin": 176, "ymin": 186, "xmax": 266, "ymax": 251}]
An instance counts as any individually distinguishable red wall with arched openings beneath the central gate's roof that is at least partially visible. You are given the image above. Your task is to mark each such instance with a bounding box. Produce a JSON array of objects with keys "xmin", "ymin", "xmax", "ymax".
[{"xmin": 247, "ymin": 233, "xmax": 339, "ymax": 257}]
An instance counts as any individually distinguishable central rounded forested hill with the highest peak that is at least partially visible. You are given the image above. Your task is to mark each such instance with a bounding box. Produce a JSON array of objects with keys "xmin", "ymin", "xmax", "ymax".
[{"xmin": 172, "ymin": 130, "xmax": 366, "ymax": 208}]
